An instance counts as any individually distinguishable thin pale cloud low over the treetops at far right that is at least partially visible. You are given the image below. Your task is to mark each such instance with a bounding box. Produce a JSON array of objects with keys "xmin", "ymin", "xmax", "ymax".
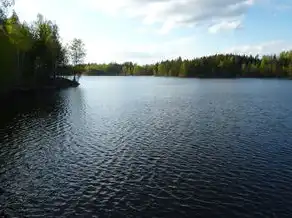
[{"xmin": 226, "ymin": 40, "xmax": 292, "ymax": 55}]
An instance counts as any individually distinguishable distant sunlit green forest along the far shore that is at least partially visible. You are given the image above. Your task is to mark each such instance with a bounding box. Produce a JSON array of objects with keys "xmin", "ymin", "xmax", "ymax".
[{"xmin": 84, "ymin": 51, "xmax": 292, "ymax": 78}]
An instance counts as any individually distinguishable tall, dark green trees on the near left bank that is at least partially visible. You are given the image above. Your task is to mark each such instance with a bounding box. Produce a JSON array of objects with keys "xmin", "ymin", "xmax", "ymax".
[{"xmin": 0, "ymin": 0, "xmax": 85, "ymax": 92}]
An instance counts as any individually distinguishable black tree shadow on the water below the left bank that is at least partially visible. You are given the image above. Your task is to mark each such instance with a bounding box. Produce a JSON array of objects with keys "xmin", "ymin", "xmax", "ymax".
[{"xmin": 0, "ymin": 89, "xmax": 77, "ymax": 147}]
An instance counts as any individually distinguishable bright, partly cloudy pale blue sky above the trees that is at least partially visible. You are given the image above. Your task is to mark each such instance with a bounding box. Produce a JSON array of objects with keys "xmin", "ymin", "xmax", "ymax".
[{"xmin": 14, "ymin": 0, "xmax": 292, "ymax": 64}]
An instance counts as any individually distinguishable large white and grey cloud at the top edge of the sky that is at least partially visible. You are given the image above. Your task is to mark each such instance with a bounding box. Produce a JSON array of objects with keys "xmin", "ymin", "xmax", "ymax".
[{"xmin": 87, "ymin": 0, "xmax": 254, "ymax": 33}]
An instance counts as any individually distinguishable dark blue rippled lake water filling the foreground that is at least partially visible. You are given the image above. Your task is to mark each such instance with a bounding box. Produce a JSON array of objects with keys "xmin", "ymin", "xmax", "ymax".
[{"xmin": 0, "ymin": 77, "xmax": 292, "ymax": 218}]
